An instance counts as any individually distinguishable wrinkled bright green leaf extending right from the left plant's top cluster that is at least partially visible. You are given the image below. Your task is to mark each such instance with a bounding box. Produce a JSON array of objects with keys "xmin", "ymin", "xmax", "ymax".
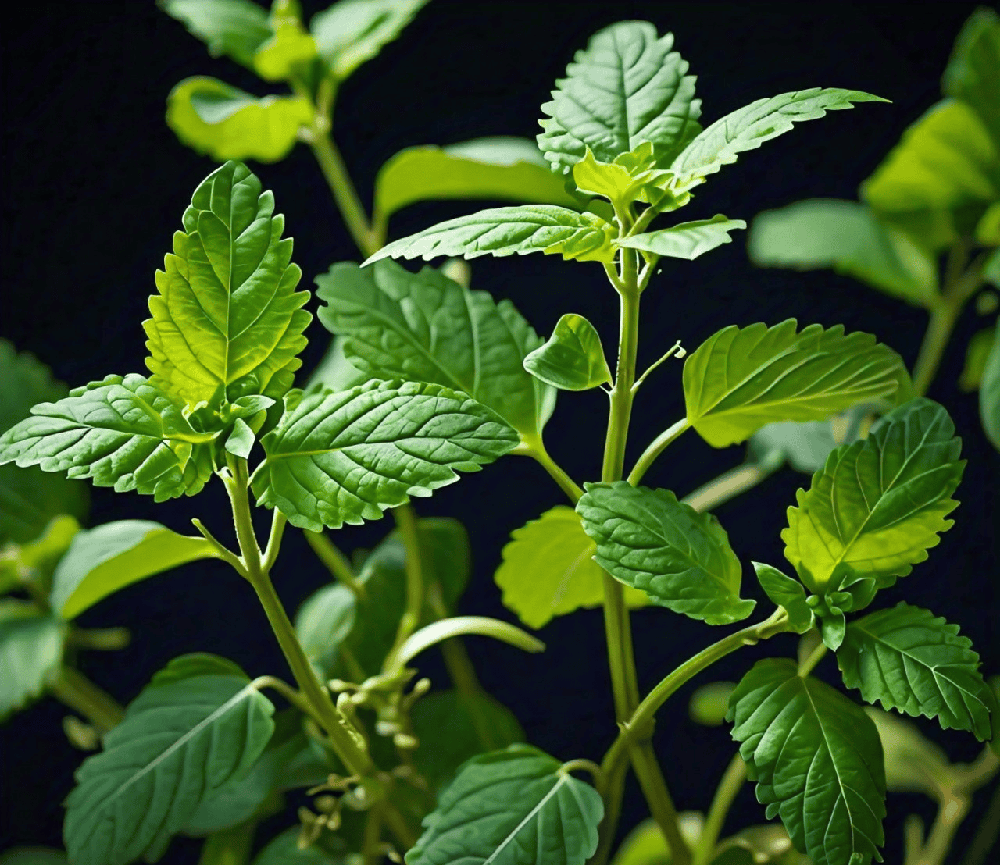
[{"xmin": 253, "ymin": 381, "xmax": 518, "ymax": 531}]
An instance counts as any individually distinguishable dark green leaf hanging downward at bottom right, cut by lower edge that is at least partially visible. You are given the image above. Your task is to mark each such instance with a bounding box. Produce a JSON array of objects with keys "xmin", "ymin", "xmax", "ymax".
[{"xmin": 729, "ymin": 659, "xmax": 885, "ymax": 865}]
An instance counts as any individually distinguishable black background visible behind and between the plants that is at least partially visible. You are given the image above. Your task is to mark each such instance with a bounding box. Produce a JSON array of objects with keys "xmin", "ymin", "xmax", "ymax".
[{"xmin": 0, "ymin": 0, "xmax": 1000, "ymax": 863}]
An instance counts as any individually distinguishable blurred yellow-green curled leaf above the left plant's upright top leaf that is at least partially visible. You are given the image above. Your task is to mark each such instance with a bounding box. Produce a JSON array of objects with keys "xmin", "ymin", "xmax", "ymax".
[{"xmin": 167, "ymin": 75, "xmax": 312, "ymax": 162}]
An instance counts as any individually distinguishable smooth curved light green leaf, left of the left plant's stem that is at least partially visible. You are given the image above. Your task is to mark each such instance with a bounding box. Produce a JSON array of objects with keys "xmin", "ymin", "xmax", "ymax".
[{"xmin": 49, "ymin": 520, "xmax": 218, "ymax": 619}]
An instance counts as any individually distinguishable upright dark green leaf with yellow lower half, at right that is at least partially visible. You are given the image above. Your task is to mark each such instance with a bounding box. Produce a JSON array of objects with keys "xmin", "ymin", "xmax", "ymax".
[{"xmin": 781, "ymin": 398, "xmax": 965, "ymax": 593}]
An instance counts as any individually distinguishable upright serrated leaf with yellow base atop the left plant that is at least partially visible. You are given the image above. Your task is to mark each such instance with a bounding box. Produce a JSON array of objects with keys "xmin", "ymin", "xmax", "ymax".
[{"xmin": 143, "ymin": 162, "xmax": 312, "ymax": 405}]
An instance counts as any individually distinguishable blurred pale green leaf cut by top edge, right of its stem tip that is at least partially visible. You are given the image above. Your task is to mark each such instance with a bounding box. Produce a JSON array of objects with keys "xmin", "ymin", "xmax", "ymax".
[{"xmin": 309, "ymin": 0, "xmax": 428, "ymax": 81}]
